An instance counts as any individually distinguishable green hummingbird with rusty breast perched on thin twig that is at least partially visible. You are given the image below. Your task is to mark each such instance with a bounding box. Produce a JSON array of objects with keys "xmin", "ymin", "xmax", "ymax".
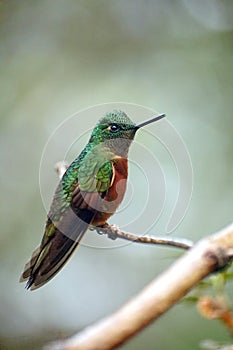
[{"xmin": 20, "ymin": 110, "xmax": 165, "ymax": 290}]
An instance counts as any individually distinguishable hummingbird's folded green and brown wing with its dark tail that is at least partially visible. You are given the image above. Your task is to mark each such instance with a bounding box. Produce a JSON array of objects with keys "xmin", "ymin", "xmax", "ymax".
[{"xmin": 20, "ymin": 155, "xmax": 113, "ymax": 289}]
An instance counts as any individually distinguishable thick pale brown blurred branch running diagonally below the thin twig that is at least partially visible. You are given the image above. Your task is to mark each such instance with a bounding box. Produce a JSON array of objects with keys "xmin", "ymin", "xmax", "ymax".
[{"xmin": 44, "ymin": 224, "xmax": 233, "ymax": 350}]
